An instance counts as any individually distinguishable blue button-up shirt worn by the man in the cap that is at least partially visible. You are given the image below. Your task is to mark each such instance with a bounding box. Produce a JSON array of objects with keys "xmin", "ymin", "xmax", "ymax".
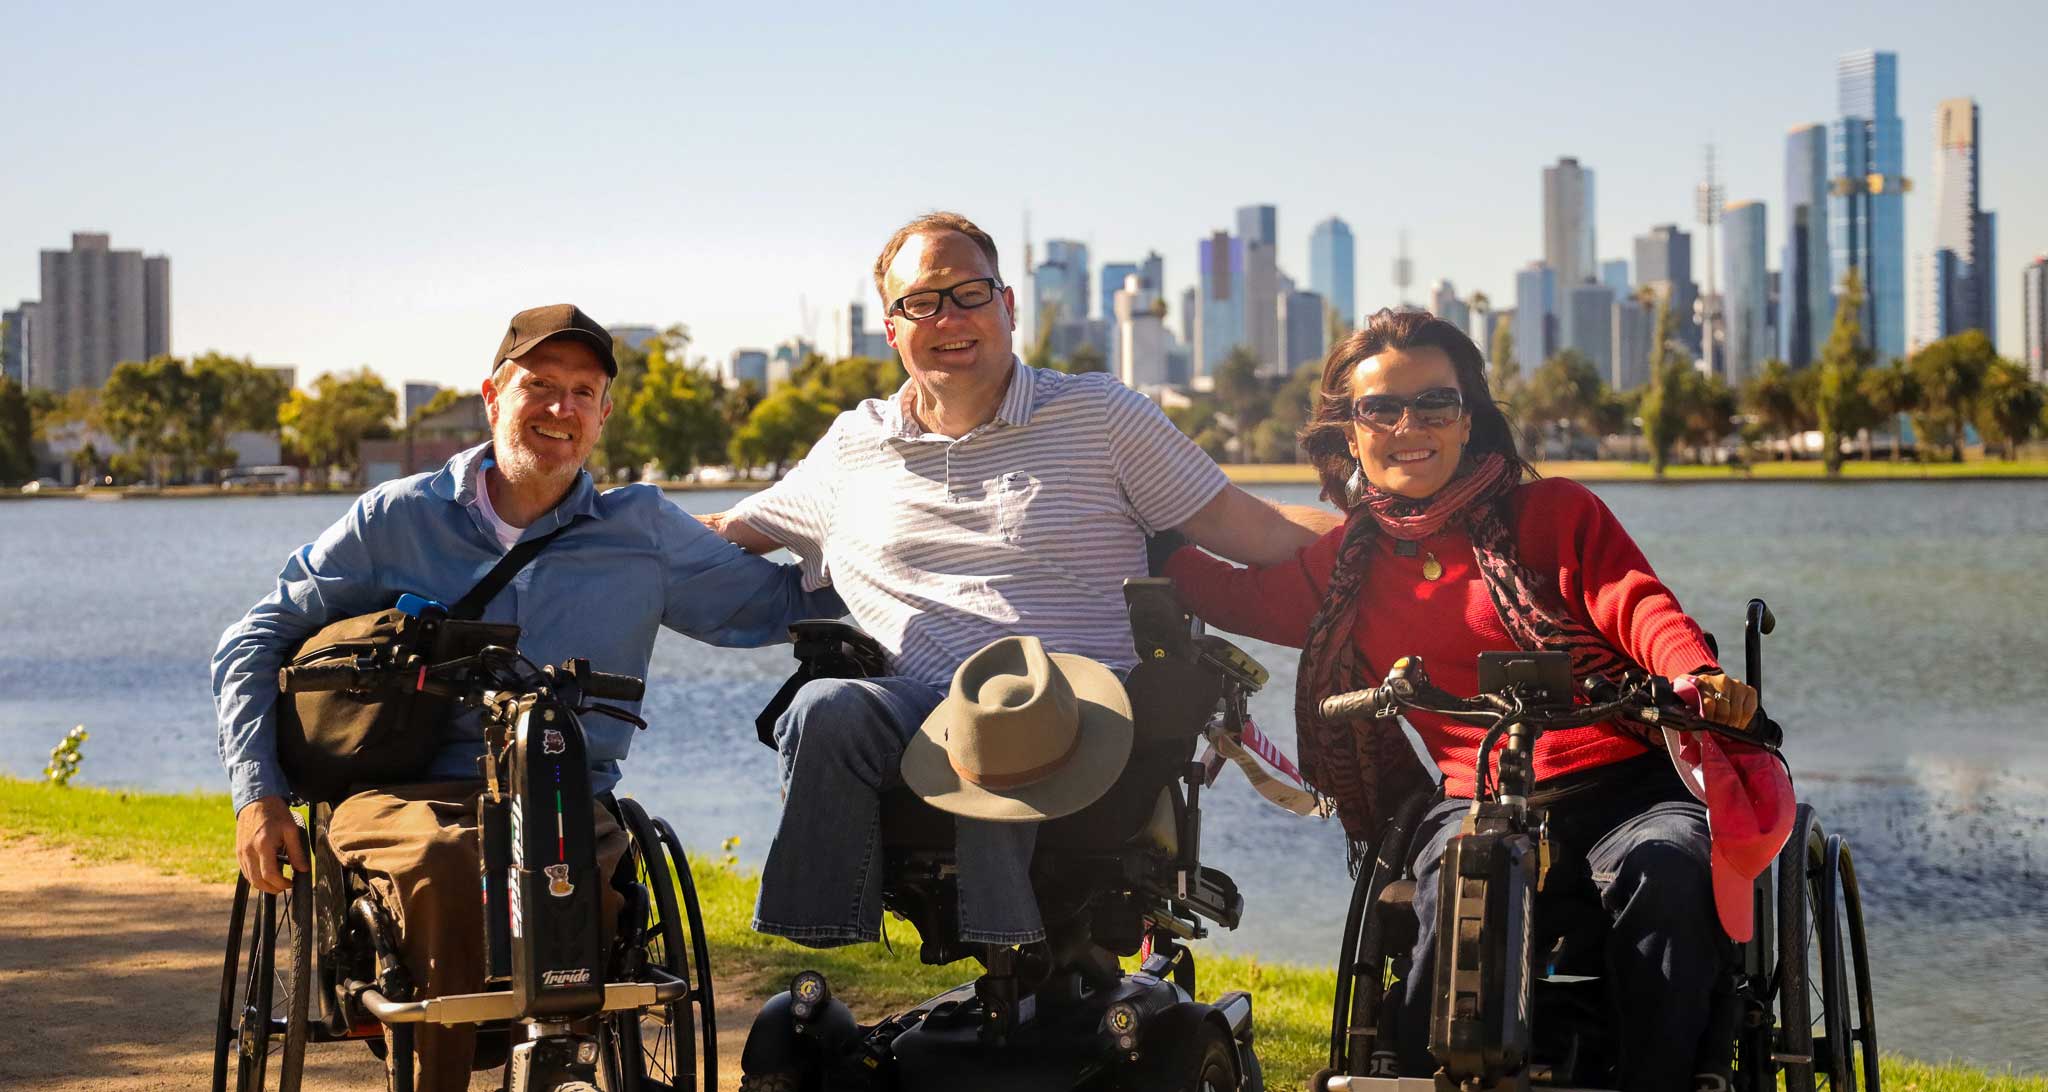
[{"xmin": 213, "ymin": 443, "xmax": 844, "ymax": 811}]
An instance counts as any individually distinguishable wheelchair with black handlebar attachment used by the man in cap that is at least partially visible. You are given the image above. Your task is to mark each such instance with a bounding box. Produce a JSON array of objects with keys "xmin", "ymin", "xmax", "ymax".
[{"xmin": 213, "ymin": 639, "xmax": 717, "ymax": 1092}]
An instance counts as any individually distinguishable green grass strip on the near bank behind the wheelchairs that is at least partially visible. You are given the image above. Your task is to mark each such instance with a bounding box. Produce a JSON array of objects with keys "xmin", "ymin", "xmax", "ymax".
[{"xmin": 0, "ymin": 776, "xmax": 2048, "ymax": 1092}]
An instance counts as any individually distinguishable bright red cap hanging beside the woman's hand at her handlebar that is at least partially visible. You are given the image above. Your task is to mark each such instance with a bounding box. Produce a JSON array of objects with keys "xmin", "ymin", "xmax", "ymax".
[{"xmin": 1665, "ymin": 731, "xmax": 1798, "ymax": 942}]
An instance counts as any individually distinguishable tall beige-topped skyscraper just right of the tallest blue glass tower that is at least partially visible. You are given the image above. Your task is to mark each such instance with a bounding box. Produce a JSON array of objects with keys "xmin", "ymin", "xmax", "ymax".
[{"xmin": 1917, "ymin": 98, "xmax": 1999, "ymax": 342}]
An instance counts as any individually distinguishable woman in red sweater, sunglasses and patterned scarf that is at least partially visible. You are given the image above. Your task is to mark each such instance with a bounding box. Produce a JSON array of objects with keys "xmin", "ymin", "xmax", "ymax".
[{"xmin": 1167, "ymin": 311, "xmax": 1757, "ymax": 1090}]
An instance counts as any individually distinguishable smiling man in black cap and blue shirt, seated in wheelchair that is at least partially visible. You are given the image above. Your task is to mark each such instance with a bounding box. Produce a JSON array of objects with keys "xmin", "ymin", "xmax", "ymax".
[{"xmin": 213, "ymin": 303, "xmax": 842, "ymax": 1092}]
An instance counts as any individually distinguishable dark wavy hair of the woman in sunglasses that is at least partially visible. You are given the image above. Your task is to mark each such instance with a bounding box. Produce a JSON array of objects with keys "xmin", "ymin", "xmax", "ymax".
[{"xmin": 1298, "ymin": 309, "xmax": 1536, "ymax": 510}]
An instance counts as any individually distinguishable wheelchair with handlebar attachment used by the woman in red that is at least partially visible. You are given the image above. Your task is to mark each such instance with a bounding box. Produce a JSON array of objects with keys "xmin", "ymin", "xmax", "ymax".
[{"xmin": 1313, "ymin": 600, "xmax": 1880, "ymax": 1092}]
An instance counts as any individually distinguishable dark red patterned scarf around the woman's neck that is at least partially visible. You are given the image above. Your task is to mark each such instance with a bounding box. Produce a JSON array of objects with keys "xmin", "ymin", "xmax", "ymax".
[{"xmin": 1294, "ymin": 455, "xmax": 1634, "ymax": 875}]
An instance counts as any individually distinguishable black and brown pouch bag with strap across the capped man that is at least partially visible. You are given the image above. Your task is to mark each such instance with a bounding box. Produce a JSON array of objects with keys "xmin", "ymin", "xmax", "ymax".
[{"xmin": 276, "ymin": 527, "xmax": 567, "ymax": 803}]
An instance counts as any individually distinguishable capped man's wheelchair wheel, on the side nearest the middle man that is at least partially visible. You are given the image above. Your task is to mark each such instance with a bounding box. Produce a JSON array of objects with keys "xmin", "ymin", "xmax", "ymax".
[{"xmin": 604, "ymin": 799, "xmax": 719, "ymax": 1092}]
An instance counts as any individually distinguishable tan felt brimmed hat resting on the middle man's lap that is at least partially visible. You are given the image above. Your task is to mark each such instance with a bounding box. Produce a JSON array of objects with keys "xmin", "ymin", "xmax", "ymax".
[{"xmin": 903, "ymin": 637, "xmax": 1130, "ymax": 824}]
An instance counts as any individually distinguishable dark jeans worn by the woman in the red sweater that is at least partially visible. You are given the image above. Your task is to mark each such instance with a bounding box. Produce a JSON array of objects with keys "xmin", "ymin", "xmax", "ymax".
[{"xmin": 1401, "ymin": 770, "xmax": 1735, "ymax": 1092}]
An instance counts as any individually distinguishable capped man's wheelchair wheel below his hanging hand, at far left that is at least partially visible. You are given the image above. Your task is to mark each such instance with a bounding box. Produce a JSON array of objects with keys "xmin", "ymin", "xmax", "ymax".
[{"xmin": 213, "ymin": 856, "xmax": 313, "ymax": 1092}]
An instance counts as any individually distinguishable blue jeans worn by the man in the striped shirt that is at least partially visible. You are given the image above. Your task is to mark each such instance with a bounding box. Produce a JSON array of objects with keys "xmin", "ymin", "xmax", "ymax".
[{"xmin": 754, "ymin": 678, "xmax": 1044, "ymax": 949}]
